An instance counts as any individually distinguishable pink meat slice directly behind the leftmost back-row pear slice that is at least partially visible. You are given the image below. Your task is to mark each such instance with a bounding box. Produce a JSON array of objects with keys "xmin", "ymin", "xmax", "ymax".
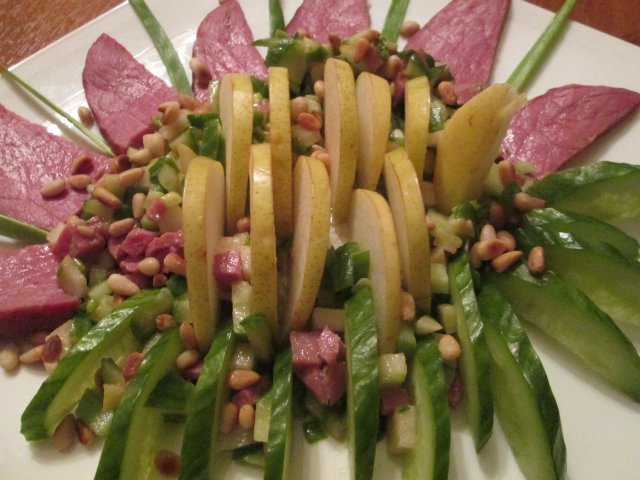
[{"xmin": 193, "ymin": 0, "xmax": 267, "ymax": 101}]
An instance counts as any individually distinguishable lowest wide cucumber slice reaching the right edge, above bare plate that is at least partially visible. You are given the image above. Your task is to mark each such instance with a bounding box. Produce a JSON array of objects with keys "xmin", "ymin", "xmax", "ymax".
[{"xmin": 483, "ymin": 264, "xmax": 640, "ymax": 401}]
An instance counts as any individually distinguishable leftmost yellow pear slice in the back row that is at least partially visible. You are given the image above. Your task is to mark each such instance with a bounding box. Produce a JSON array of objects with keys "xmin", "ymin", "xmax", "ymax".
[{"xmin": 220, "ymin": 73, "xmax": 253, "ymax": 235}]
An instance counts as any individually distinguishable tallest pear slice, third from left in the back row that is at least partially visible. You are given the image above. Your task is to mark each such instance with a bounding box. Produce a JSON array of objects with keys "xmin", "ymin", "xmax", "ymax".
[{"xmin": 324, "ymin": 58, "xmax": 359, "ymax": 223}]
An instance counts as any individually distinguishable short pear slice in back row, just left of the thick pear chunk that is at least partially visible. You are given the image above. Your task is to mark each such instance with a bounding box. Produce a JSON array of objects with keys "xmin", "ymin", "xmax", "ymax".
[{"xmin": 404, "ymin": 76, "xmax": 431, "ymax": 180}]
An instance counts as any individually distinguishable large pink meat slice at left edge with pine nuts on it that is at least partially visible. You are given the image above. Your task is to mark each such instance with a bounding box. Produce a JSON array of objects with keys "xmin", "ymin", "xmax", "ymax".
[{"xmin": 0, "ymin": 105, "xmax": 108, "ymax": 230}]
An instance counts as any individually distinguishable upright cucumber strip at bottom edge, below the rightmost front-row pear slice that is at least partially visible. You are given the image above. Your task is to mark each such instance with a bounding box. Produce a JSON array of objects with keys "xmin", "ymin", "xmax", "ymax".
[{"xmin": 403, "ymin": 336, "xmax": 451, "ymax": 480}]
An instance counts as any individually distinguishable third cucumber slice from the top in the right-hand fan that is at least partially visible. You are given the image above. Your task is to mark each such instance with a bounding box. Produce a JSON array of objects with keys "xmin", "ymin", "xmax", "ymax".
[{"xmin": 516, "ymin": 225, "xmax": 640, "ymax": 326}]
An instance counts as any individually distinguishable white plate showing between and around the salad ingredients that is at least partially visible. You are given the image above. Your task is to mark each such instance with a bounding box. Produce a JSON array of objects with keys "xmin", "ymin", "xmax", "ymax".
[{"xmin": 0, "ymin": 0, "xmax": 640, "ymax": 480}]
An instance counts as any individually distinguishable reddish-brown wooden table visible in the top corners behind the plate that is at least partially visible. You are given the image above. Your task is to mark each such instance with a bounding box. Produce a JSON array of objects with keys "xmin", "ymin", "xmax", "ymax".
[{"xmin": 0, "ymin": 0, "xmax": 640, "ymax": 66}]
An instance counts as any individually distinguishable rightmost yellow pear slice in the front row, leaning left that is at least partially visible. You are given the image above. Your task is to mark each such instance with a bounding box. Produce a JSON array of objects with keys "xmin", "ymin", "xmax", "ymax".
[{"xmin": 384, "ymin": 148, "xmax": 431, "ymax": 310}]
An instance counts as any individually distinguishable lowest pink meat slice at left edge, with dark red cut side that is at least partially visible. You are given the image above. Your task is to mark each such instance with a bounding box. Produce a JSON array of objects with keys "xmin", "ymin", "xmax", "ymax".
[{"xmin": 0, "ymin": 245, "xmax": 80, "ymax": 337}]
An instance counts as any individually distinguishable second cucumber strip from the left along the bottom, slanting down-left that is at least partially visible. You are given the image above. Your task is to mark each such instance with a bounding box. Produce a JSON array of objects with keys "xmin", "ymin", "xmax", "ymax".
[{"xmin": 95, "ymin": 329, "xmax": 184, "ymax": 480}]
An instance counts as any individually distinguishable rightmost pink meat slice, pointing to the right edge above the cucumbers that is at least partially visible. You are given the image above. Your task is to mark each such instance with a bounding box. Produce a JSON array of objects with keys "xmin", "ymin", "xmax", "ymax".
[{"xmin": 502, "ymin": 85, "xmax": 640, "ymax": 178}]
